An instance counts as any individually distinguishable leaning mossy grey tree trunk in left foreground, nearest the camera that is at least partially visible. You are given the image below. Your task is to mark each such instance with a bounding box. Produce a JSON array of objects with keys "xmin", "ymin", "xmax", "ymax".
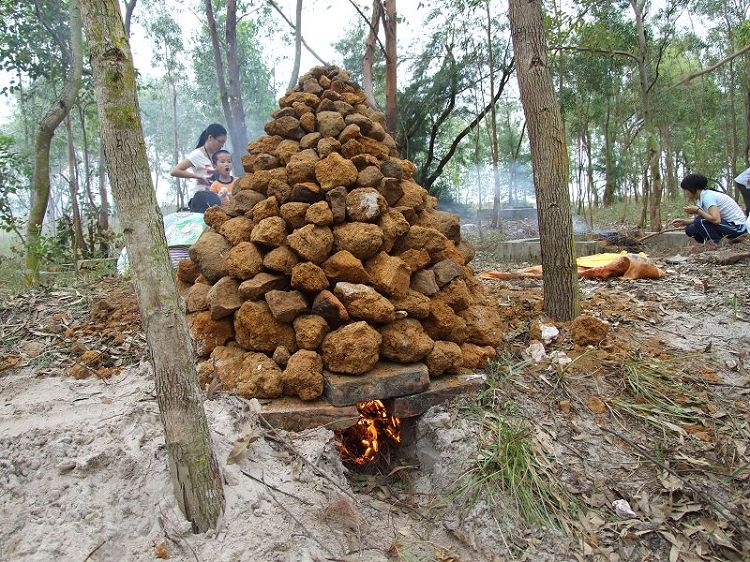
[{"xmin": 82, "ymin": 0, "xmax": 224, "ymax": 532}]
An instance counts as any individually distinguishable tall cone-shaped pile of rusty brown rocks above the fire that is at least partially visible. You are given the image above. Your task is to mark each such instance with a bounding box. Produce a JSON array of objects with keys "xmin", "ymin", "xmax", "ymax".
[{"xmin": 178, "ymin": 67, "xmax": 501, "ymax": 416}]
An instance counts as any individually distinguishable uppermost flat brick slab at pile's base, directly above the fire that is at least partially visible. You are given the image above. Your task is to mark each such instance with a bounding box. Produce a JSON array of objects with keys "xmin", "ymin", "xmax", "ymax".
[{"xmin": 323, "ymin": 361, "xmax": 430, "ymax": 406}]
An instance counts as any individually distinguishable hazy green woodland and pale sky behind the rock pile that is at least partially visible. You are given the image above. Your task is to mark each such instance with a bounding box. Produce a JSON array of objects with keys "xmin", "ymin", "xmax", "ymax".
[{"xmin": 0, "ymin": 0, "xmax": 750, "ymax": 272}]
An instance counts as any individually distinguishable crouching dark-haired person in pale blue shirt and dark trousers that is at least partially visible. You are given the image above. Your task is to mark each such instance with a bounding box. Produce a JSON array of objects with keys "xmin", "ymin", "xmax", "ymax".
[{"xmin": 672, "ymin": 174, "xmax": 747, "ymax": 243}]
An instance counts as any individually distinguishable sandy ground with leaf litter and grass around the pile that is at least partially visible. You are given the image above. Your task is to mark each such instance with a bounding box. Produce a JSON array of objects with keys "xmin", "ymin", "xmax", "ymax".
[{"xmin": 0, "ymin": 233, "xmax": 750, "ymax": 562}]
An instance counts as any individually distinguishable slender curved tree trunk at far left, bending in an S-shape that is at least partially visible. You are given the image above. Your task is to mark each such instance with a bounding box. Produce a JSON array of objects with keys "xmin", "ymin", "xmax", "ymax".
[{"xmin": 26, "ymin": 0, "xmax": 83, "ymax": 283}]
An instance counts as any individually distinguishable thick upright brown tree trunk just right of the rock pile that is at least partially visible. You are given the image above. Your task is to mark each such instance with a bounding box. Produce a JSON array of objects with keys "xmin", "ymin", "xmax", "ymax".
[{"xmin": 509, "ymin": 0, "xmax": 580, "ymax": 321}]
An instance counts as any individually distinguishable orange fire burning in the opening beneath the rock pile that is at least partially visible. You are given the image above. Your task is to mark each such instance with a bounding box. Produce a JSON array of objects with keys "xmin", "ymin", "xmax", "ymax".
[{"xmin": 335, "ymin": 400, "xmax": 401, "ymax": 465}]
